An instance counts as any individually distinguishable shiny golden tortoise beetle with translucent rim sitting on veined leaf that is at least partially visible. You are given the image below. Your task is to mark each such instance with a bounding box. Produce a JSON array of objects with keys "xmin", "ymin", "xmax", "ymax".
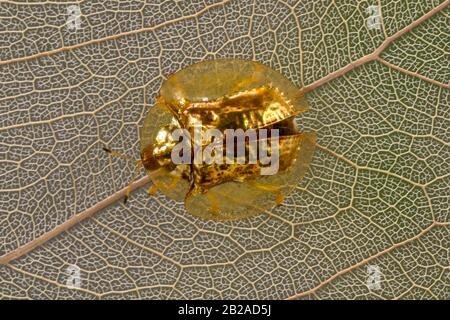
[{"xmin": 105, "ymin": 59, "xmax": 316, "ymax": 221}]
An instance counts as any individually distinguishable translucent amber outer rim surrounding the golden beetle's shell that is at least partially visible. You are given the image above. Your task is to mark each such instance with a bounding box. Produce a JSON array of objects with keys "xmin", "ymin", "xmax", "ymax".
[{"xmin": 141, "ymin": 59, "xmax": 315, "ymax": 220}]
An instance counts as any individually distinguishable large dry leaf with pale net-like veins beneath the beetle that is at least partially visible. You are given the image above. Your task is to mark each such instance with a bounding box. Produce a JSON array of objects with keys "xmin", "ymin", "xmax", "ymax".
[{"xmin": 0, "ymin": 0, "xmax": 450, "ymax": 299}]
